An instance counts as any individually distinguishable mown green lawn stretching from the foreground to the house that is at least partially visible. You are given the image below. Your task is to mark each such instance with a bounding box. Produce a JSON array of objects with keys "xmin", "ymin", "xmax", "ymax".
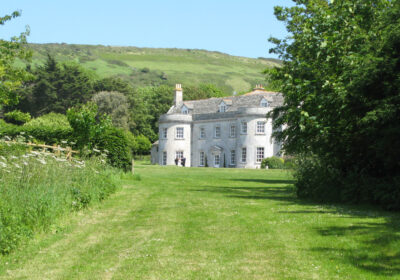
[{"xmin": 0, "ymin": 165, "xmax": 400, "ymax": 279}]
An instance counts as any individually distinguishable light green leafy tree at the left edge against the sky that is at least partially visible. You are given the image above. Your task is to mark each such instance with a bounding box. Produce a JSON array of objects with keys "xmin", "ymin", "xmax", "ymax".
[{"xmin": 0, "ymin": 11, "xmax": 32, "ymax": 109}]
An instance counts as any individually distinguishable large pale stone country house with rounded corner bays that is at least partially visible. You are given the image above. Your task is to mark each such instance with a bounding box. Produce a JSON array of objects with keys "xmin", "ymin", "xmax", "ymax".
[{"xmin": 151, "ymin": 84, "xmax": 283, "ymax": 168}]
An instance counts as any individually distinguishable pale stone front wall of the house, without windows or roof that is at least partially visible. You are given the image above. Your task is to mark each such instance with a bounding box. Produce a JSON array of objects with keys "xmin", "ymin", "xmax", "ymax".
[{"xmin": 158, "ymin": 108, "xmax": 280, "ymax": 168}]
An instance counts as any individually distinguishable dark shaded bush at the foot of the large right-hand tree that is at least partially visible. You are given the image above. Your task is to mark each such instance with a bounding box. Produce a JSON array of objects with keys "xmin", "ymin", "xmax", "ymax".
[{"xmin": 294, "ymin": 157, "xmax": 400, "ymax": 210}]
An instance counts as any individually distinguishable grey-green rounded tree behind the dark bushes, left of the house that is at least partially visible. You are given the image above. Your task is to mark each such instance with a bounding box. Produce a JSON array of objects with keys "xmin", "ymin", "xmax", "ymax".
[{"xmin": 92, "ymin": 91, "xmax": 129, "ymax": 130}]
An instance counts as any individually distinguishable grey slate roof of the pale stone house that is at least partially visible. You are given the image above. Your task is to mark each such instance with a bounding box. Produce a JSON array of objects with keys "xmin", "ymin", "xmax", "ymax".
[{"xmin": 168, "ymin": 90, "xmax": 283, "ymax": 116}]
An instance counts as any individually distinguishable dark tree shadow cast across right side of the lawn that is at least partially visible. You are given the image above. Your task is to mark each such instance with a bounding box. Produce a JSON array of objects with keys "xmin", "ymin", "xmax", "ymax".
[{"xmin": 194, "ymin": 176, "xmax": 400, "ymax": 279}]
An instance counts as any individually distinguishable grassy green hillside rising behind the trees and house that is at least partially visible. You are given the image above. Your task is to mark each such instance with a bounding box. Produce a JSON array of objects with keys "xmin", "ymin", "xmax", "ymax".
[{"xmin": 23, "ymin": 44, "xmax": 279, "ymax": 93}]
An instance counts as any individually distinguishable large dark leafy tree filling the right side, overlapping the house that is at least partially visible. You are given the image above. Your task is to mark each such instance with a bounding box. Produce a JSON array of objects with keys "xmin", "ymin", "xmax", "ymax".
[{"xmin": 267, "ymin": 0, "xmax": 400, "ymax": 208}]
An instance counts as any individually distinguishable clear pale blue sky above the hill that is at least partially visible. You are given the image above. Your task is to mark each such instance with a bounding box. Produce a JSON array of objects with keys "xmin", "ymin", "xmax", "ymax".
[{"xmin": 0, "ymin": 0, "xmax": 293, "ymax": 58}]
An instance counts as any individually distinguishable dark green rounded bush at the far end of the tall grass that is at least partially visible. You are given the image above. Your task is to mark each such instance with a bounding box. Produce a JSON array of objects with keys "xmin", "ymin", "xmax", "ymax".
[{"xmin": 96, "ymin": 127, "xmax": 132, "ymax": 170}]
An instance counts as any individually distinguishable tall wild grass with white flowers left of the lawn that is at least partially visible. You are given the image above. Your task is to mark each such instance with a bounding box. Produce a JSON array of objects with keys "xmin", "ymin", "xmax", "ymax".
[{"xmin": 0, "ymin": 142, "xmax": 119, "ymax": 254}]
